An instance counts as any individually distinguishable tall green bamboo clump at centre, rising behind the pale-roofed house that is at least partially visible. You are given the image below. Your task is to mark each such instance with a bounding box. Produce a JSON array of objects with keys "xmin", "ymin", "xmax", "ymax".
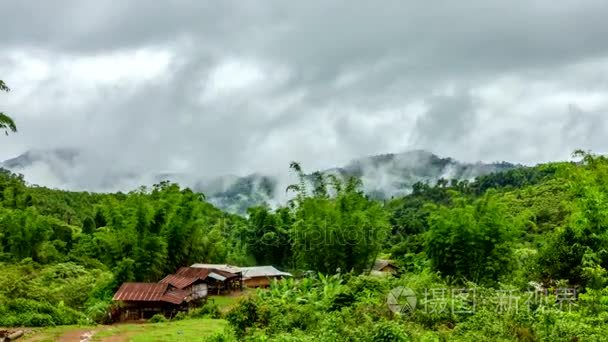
[{"xmin": 286, "ymin": 163, "xmax": 390, "ymax": 273}]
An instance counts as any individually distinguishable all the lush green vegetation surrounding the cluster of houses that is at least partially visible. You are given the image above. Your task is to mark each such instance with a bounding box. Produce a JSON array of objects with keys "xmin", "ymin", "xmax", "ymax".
[{"xmin": 0, "ymin": 152, "xmax": 608, "ymax": 341}]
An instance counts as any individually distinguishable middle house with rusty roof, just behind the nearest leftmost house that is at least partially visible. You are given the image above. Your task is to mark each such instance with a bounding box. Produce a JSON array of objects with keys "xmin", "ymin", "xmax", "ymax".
[{"xmin": 172, "ymin": 267, "xmax": 242, "ymax": 294}]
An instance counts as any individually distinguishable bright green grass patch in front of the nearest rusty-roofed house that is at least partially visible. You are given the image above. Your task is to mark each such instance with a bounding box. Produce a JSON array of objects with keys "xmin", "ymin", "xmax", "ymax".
[{"xmin": 93, "ymin": 318, "xmax": 227, "ymax": 342}]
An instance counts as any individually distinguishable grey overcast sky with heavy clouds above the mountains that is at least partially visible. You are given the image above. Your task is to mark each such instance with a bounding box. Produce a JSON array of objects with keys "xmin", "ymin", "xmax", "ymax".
[{"xmin": 0, "ymin": 0, "xmax": 608, "ymax": 179}]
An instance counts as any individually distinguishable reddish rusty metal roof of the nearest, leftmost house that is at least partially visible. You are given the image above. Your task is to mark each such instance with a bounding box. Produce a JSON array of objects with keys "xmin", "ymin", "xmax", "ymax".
[{"xmin": 112, "ymin": 283, "xmax": 188, "ymax": 304}]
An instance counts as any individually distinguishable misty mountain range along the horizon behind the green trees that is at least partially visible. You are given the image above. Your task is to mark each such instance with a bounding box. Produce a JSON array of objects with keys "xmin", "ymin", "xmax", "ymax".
[{"xmin": 0, "ymin": 149, "xmax": 518, "ymax": 214}]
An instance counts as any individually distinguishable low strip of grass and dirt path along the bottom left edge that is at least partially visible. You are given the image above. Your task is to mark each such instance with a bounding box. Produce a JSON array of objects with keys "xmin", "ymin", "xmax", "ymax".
[{"xmin": 24, "ymin": 318, "xmax": 227, "ymax": 342}]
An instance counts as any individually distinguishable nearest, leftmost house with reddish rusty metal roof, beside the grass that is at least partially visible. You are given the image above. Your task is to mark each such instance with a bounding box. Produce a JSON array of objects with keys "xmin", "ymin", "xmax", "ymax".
[{"xmin": 112, "ymin": 283, "xmax": 189, "ymax": 321}]
